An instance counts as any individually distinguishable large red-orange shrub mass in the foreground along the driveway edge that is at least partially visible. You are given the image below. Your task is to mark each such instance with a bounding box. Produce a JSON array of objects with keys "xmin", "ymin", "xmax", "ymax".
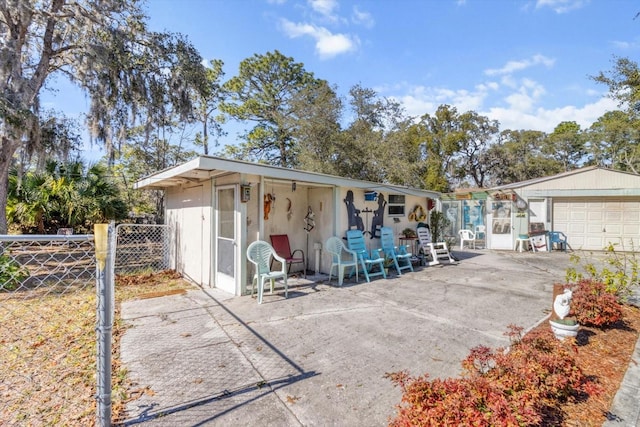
[{"xmin": 389, "ymin": 327, "xmax": 598, "ymax": 426}]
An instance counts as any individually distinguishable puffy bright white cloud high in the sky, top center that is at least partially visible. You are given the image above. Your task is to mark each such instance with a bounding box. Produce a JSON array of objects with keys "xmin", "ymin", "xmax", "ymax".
[{"xmin": 281, "ymin": 19, "xmax": 360, "ymax": 58}]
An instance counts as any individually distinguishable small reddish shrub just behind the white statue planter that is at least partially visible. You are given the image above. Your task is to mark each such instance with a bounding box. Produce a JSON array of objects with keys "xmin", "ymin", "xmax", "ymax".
[{"xmin": 569, "ymin": 279, "xmax": 622, "ymax": 327}]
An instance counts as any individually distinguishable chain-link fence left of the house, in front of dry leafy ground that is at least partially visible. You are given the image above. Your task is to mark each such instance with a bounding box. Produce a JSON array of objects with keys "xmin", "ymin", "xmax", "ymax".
[{"xmin": 0, "ymin": 224, "xmax": 171, "ymax": 426}]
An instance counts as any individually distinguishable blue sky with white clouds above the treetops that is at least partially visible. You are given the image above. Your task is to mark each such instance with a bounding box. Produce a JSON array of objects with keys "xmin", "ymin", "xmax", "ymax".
[{"xmin": 43, "ymin": 0, "xmax": 640, "ymax": 159}]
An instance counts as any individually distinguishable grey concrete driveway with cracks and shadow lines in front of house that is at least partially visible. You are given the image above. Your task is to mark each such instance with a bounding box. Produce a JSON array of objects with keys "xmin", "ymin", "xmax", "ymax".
[{"xmin": 121, "ymin": 250, "xmax": 570, "ymax": 426}]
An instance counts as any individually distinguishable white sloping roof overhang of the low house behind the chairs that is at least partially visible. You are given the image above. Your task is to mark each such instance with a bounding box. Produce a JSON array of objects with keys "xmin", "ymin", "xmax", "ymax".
[{"xmin": 133, "ymin": 156, "xmax": 440, "ymax": 199}]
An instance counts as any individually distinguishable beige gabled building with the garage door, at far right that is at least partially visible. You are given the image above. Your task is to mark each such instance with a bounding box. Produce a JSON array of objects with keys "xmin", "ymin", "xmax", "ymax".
[{"xmin": 486, "ymin": 166, "xmax": 640, "ymax": 251}]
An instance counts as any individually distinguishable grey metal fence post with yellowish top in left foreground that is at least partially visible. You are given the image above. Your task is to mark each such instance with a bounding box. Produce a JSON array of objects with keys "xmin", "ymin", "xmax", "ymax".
[{"xmin": 94, "ymin": 223, "xmax": 115, "ymax": 427}]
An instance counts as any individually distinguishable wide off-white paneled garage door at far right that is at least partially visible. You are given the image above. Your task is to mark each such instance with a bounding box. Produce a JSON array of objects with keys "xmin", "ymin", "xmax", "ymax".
[{"xmin": 553, "ymin": 197, "xmax": 640, "ymax": 250}]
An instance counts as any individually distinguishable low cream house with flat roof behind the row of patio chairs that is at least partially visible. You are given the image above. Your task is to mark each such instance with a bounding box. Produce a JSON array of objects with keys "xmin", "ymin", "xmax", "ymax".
[{"xmin": 135, "ymin": 156, "xmax": 440, "ymax": 295}]
